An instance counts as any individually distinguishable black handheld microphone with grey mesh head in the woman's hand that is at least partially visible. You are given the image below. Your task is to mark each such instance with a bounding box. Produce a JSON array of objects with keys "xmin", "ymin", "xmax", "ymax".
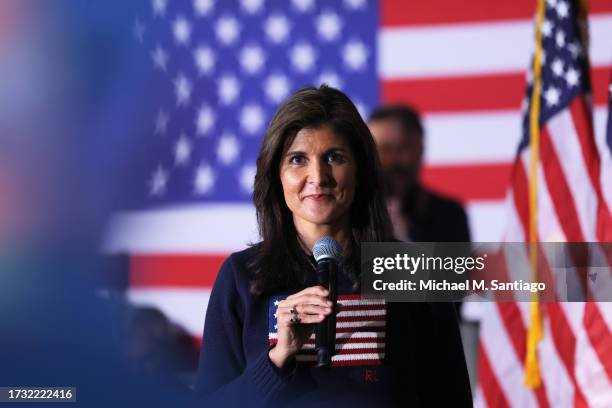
[{"xmin": 312, "ymin": 237, "xmax": 342, "ymax": 368}]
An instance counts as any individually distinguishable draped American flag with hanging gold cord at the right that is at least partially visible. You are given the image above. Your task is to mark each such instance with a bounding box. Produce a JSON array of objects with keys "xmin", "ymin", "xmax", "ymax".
[{"xmin": 477, "ymin": 0, "xmax": 612, "ymax": 407}]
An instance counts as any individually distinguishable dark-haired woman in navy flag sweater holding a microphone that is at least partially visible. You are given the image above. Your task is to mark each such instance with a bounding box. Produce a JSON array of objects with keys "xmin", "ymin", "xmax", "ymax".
[{"xmin": 196, "ymin": 85, "xmax": 471, "ymax": 407}]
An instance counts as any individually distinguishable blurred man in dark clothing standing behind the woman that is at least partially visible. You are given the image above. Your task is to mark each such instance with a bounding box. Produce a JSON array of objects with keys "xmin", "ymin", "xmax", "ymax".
[{"xmin": 368, "ymin": 105, "xmax": 470, "ymax": 242}]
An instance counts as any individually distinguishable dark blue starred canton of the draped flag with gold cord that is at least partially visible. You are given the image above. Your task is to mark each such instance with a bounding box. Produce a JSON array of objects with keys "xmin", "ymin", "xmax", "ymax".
[{"xmin": 519, "ymin": 0, "xmax": 591, "ymax": 153}]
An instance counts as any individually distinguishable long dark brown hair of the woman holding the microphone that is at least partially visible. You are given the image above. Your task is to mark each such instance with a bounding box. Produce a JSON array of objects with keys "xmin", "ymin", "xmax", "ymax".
[{"xmin": 249, "ymin": 85, "xmax": 393, "ymax": 296}]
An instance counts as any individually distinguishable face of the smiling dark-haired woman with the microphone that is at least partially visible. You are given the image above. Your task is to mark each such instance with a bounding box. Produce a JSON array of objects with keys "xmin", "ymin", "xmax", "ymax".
[{"xmin": 280, "ymin": 126, "xmax": 357, "ymax": 227}]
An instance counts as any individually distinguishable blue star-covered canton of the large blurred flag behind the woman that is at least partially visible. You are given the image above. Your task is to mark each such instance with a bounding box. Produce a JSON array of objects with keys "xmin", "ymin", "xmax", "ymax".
[{"xmin": 132, "ymin": 0, "xmax": 378, "ymax": 207}]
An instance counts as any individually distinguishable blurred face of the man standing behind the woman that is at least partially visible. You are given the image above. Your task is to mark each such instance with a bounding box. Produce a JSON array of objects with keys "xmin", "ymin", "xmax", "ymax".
[{"xmin": 369, "ymin": 119, "xmax": 423, "ymax": 197}]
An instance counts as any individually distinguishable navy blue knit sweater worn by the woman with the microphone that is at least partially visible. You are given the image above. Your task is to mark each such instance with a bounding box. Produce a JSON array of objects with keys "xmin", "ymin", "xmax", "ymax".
[{"xmin": 196, "ymin": 247, "xmax": 472, "ymax": 407}]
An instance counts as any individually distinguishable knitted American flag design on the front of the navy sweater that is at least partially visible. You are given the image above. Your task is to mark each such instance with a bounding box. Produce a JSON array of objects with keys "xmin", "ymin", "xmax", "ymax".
[{"xmin": 268, "ymin": 295, "xmax": 387, "ymax": 366}]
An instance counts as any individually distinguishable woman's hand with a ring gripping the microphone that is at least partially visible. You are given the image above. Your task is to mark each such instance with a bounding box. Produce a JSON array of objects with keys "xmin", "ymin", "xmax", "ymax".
[{"xmin": 268, "ymin": 286, "xmax": 332, "ymax": 368}]
